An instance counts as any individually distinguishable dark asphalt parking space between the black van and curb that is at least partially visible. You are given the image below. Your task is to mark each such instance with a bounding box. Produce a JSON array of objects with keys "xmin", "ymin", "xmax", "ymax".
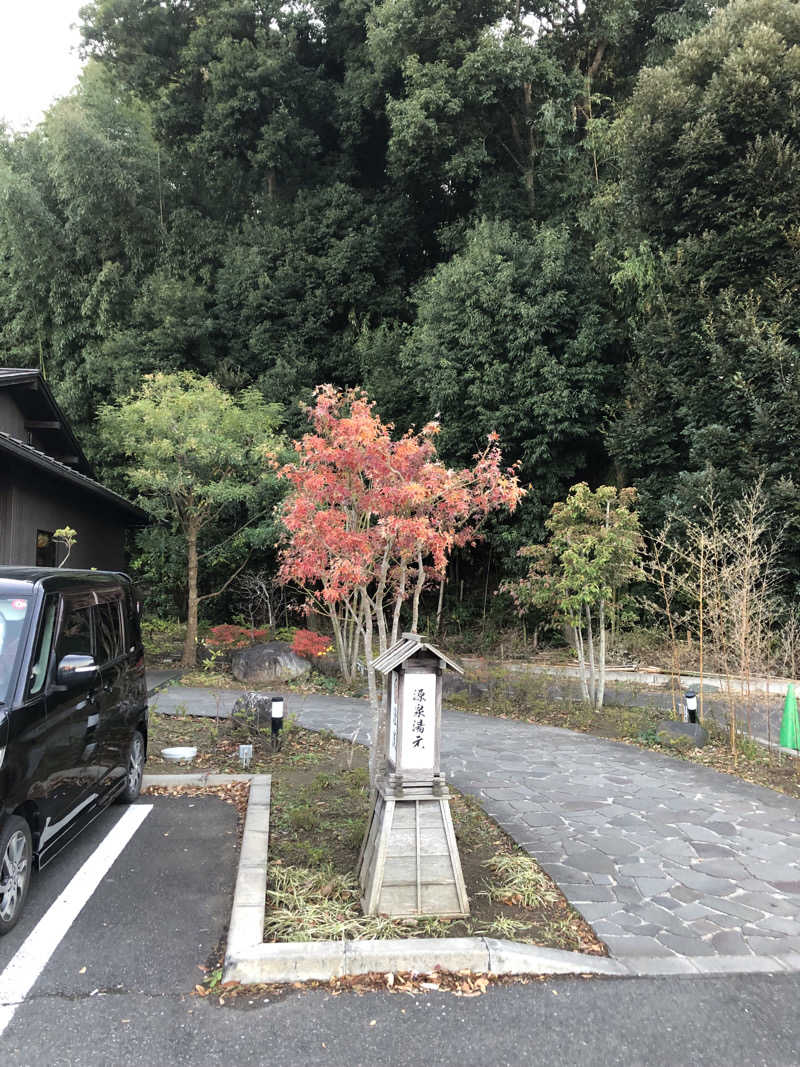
[{"xmin": 0, "ymin": 796, "xmax": 238, "ymax": 1063}]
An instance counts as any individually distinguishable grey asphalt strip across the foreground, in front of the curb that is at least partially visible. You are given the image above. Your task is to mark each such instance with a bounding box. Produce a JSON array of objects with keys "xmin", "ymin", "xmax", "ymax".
[{"xmin": 0, "ymin": 974, "xmax": 800, "ymax": 1067}]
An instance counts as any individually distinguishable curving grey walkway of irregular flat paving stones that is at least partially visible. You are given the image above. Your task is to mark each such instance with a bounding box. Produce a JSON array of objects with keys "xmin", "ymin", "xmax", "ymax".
[{"xmin": 150, "ymin": 688, "xmax": 800, "ymax": 970}]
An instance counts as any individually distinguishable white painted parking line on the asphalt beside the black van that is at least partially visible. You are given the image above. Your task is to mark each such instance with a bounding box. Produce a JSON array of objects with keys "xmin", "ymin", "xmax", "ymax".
[{"xmin": 0, "ymin": 803, "xmax": 153, "ymax": 1035}]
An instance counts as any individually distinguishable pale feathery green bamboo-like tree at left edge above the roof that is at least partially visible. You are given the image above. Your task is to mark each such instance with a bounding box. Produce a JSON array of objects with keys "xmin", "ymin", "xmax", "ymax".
[{"xmin": 0, "ymin": 64, "xmax": 162, "ymax": 421}]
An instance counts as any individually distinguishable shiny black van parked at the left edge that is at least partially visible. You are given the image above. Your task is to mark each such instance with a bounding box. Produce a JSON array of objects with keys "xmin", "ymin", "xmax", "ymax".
[{"xmin": 0, "ymin": 567, "xmax": 147, "ymax": 935}]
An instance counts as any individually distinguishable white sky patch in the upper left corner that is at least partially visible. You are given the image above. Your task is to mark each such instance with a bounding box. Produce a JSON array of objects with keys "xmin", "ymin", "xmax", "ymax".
[{"xmin": 0, "ymin": 0, "xmax": 85, "ymax": 129}]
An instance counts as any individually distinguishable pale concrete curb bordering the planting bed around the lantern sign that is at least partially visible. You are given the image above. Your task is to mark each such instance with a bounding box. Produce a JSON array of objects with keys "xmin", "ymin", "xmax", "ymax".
[{"xmin": 142, "ymin": 774, "xmax": 800, "ymax": 985}]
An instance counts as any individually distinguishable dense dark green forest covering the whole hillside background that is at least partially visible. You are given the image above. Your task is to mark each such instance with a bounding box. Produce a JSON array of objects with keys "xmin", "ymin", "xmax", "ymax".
[{"xmin": 0, "ymin": 0, "xmax": 800, "ymax": 627}]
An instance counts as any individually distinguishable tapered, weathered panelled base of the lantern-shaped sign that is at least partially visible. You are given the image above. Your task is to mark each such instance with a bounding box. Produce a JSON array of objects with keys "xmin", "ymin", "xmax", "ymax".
[{"xmin": 358, "ymin": 783, "xmax": 469, "ymax": 918}]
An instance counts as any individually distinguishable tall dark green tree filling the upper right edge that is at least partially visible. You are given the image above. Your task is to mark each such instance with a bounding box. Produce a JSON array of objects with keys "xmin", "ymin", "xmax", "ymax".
[{"xmin": 598, "ymin": 0, "xmax": 800, "ymax": 542}]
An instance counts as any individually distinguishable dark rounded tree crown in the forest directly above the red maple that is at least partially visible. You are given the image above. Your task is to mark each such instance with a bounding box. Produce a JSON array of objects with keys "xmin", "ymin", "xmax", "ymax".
[{"xmin": 214, "ymin": 182, "xmax": 413, "ymax": 405}]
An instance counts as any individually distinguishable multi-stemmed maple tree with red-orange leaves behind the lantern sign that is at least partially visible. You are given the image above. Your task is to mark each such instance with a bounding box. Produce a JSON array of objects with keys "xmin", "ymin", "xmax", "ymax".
[{"xmin": 278, "ymin": 385, "xmax": 524, "ymax": 706}]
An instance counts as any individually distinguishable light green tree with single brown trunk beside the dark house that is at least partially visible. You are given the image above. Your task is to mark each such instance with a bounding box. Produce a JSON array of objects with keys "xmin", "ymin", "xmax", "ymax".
[{"xmin": 99, "ymin": 371, "xmax": 279, "ymax": 666}]
